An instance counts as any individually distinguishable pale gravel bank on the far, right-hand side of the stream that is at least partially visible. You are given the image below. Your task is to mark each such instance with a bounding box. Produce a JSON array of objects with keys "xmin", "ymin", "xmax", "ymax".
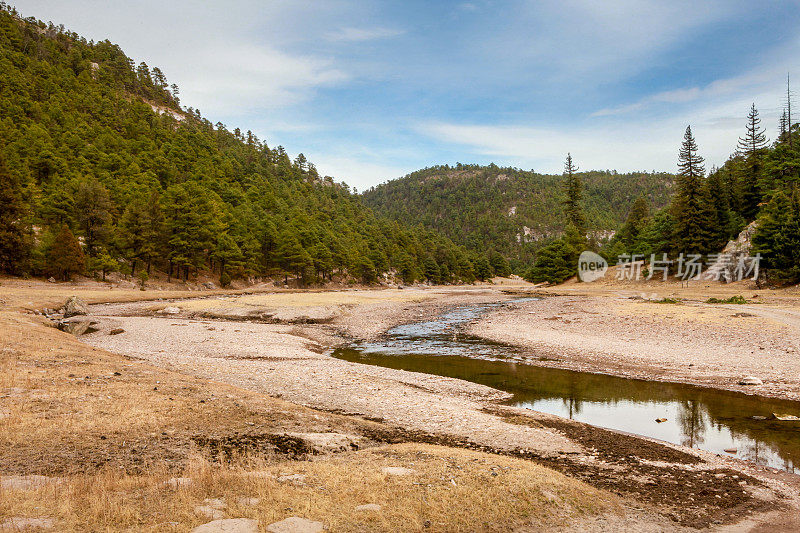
[{"xmin": 471, "ymin": 295, "xmax": 800, "ymax": 400}]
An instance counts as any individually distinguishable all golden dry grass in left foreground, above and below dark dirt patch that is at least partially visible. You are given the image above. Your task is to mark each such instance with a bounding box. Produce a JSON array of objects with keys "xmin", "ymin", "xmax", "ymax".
[{"xmin": 0, "ymin": 291, "xmax": 618, "ymax": 531}]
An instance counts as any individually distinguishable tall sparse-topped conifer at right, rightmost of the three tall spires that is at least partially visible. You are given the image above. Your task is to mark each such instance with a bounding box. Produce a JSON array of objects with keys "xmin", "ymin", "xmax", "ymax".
[{"xmin": 736, "ymin": 104, "xmax": 768, "ymax": 220}]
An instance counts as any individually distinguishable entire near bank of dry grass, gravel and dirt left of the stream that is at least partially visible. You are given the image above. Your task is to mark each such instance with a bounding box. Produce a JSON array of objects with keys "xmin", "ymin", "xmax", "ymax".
[{"xmin": 0, "ymin": 276, "xmax": 798, "ymax": 531}]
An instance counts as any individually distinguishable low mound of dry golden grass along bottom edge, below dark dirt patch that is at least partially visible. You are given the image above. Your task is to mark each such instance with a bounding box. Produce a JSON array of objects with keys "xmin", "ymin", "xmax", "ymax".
[{"xmin": 0, "ymin": 444, "xmax": 619, "ymax": 531}]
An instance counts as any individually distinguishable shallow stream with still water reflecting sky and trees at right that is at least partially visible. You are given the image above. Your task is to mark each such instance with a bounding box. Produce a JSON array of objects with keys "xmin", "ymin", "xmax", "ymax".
[{"xmin": 334, "ymin": 306, "xmax": 800, "ymax": 472}]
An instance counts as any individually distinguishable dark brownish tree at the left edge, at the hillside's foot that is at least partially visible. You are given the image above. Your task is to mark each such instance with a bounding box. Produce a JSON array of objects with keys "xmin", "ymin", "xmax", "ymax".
[{"xmin": 0, "ymin": 155, "xmax": 29, "ymax": 274}]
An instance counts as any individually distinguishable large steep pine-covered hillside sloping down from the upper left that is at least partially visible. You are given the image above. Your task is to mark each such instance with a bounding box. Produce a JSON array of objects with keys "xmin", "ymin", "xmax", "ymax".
[{"xmin": 0, "ymin": 4, "xmax": 482, "ymax": 285}]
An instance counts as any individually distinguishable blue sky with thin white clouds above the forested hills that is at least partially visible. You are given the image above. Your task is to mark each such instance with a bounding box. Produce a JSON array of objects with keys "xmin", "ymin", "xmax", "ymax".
[{"xmin": 9, "ymin": 0, "xmax": 800, "ymax": 190}]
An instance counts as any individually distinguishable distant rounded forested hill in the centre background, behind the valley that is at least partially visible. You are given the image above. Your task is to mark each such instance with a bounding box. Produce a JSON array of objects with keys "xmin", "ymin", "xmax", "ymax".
[{"xmin": 362, "ymin": 164, "xmax": 675, "ymax": 271}]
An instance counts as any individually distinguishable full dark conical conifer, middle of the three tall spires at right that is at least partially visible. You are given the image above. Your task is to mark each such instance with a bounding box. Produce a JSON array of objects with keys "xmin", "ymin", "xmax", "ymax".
[{"xmin": 671, "ymin": 126, "xmax": 714, "ymax": 254}]
